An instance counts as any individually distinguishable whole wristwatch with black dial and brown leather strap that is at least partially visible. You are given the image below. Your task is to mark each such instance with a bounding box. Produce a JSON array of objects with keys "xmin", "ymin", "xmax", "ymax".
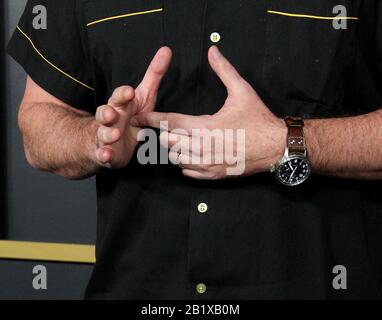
[{"xmin": 271, "ymin": 117, "xmax": 311, "ymax": 186}]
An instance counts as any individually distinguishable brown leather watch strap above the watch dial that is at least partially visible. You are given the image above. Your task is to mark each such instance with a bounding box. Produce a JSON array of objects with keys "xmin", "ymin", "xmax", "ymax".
[{"xmin": 285, "ymin": 117, "xmax": 306, "ymax": 154}]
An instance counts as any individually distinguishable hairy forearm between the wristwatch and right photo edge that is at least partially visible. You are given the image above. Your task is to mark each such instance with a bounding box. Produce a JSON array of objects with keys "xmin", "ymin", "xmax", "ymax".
[{"xmin": 305, "ymin": 110, "xmax": 382, "ymax": 180}]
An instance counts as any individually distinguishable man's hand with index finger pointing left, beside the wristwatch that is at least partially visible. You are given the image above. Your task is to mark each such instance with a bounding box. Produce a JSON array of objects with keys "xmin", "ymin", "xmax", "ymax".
[{"xmin": 131, "ymin": 46, "xmax": 286, "ymax": 179}]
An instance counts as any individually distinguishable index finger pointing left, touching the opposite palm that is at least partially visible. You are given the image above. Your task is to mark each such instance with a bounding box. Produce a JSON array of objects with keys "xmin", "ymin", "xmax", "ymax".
[{"xmin": 130, "ymin": 112, "xmax": 208, "ymax": 134}]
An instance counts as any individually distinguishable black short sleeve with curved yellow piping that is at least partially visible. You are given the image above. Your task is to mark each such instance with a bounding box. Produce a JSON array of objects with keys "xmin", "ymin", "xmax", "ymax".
[{"xmin": 7, "ymin": 0, "xmax": 94, "ymax": 111}]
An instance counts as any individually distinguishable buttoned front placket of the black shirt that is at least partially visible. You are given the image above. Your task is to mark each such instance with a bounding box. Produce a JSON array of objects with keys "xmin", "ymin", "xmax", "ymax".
[{"xmin": 188, "ymin": 0, "xmax": 220, "ymax": 300}]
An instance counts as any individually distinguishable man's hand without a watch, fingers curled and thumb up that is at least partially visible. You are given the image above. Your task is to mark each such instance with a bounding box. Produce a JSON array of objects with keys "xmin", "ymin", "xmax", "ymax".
[{"xmin": 94, "ymin": 47, "xmax": 172, "ymax": 169}]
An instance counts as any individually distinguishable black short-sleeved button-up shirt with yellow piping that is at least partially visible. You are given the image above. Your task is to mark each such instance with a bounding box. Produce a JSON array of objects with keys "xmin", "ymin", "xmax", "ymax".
[{"xmin": 9, "ymin": 0, "xmax": 382, "ymax": 299}]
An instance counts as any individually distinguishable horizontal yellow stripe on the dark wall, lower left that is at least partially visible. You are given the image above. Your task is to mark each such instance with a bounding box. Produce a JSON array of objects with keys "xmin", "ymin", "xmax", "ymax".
[{"xmin": 0, "ymin": 240, "xmax": 96, "ymax": 263}]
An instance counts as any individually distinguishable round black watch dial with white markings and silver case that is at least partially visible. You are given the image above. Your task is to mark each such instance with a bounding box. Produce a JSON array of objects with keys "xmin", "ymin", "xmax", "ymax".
[{"xmin": 277, "ymin": 156, "xmax": 310, "ymax": 186}]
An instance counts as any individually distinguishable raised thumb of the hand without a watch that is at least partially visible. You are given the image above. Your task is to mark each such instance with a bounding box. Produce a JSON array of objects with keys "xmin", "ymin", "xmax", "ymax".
[{"xmin": 137, "ymin": 47, "xmax": 172, "ymax": 97}]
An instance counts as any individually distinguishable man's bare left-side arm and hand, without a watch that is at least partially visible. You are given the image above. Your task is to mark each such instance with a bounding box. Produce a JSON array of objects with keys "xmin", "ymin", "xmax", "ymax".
[{"xmin": 19, "ymin": 47, "xmax": 172, "ymax": 179}]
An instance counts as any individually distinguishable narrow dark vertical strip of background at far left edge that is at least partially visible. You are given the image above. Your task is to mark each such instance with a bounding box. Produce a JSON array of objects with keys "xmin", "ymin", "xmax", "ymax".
[{"xmin": 0, "ymin": 1, "xmax": 6, "ymax": 238}]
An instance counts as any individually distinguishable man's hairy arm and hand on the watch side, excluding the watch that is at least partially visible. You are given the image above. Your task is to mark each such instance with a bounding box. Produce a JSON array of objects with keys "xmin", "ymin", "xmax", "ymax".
[{"xmin": 132, "ymin": 46, "xmax": 382, "ymax": 180}]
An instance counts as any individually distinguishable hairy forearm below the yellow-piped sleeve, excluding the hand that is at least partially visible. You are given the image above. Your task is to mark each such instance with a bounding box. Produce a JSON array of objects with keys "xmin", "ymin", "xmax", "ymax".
[{"xmin": 19, "ymin": 103, "xmax": 99, "ymax": 179}]
